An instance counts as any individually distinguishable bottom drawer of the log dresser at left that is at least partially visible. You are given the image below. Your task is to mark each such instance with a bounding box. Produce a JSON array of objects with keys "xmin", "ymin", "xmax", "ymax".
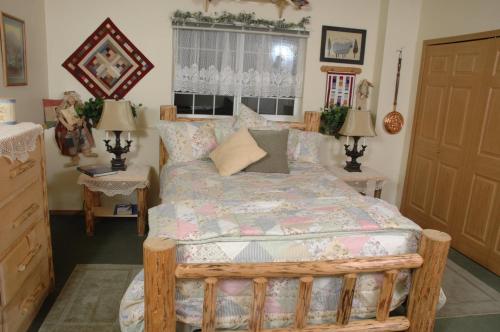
[{"xmin": 2, "ymin": 261, "xmax": 50, "ymax": 332}]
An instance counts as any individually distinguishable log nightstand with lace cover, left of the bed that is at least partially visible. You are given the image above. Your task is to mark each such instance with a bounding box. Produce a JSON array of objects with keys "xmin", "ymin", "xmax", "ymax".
[{"xmin": 78, "ymin": 165, "xmax": 151, "ymax": 236}]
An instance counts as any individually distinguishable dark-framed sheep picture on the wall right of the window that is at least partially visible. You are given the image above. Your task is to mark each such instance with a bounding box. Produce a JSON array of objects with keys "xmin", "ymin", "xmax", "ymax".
[{"xmin": 320, "ymin": 25, "xmax": 366, "ymax": 65}]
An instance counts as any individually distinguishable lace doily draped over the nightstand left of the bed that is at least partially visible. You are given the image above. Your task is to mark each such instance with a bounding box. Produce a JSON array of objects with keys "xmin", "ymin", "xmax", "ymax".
[{"xmin": 78, "ymin": 165, "xmax": 150, "ymax": 196}]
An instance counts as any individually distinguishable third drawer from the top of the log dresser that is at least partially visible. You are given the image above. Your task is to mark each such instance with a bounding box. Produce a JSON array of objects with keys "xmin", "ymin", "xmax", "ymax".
[{"xmin": 0, "ymin": 222, "xmax": 48, "ymax": 306}]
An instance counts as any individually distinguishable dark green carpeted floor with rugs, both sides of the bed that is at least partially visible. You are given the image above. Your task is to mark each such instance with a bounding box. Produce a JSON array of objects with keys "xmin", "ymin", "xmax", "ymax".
[{"xmin": 30, "ymin": 216, "xmax": 500, "ymax": 332}]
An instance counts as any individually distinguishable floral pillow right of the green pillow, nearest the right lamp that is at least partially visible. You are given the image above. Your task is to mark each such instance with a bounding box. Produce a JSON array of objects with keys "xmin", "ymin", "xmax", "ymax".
[{"xmin": 287, "ymin": 129, "xmax": 325, "ymax": 164}]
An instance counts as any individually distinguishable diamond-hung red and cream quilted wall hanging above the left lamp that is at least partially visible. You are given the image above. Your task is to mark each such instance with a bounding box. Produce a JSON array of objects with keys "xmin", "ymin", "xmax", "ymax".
[{"xmin": 63, "ymin": 18, "xmax": 154, "ymax": 99}]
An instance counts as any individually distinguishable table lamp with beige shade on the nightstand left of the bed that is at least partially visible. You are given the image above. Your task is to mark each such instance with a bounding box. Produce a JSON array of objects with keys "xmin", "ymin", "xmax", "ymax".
[{"xmin": 97, "ymin": 99, "xmax": 136, "ymax": 171}]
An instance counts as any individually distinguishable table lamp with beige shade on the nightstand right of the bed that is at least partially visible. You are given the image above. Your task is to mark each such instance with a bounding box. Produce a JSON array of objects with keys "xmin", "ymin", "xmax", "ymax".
[{"xmin": 339, "ymin": 109, "xmax": 377, "ymax": 172}]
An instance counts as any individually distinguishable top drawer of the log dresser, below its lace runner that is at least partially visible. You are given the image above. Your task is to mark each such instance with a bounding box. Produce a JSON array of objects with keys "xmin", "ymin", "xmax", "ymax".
[{"xmin": 0, "ymin": 144, "xmax": 41, "ymax": 206}]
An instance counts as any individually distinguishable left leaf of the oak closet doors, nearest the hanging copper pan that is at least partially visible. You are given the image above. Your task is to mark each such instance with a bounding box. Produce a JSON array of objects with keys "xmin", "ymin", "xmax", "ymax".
[{"xmin": 402, "ymin": 40, "xmax": 488, "ymax": 234}]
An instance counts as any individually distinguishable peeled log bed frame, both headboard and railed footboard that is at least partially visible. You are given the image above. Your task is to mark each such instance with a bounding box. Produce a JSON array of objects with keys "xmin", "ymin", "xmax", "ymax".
[{"xmin": 144, "ymin": 106, "xmax": 451, "ymax": 332}]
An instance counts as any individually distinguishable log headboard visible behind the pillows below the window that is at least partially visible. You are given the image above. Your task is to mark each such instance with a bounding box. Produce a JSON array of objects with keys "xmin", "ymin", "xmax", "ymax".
[{"xmin": 160, "ymin": 105, "xmax": 321, "ymax": 170}]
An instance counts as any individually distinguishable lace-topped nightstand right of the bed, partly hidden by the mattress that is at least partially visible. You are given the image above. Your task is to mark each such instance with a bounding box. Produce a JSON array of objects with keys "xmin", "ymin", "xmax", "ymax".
[{"xmin": 328, "ymin": 165, "xmax": 387, "ymax": 198}]
